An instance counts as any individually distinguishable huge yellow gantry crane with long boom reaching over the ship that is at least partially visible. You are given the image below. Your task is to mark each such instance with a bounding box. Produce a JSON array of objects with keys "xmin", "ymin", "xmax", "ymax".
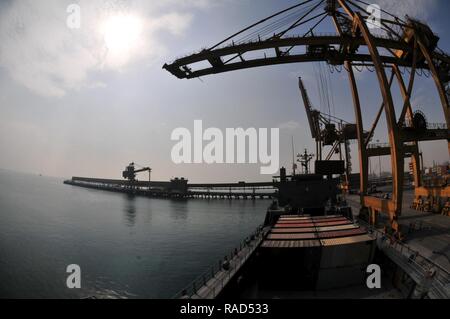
[{"xmin": 163, "ymin": 0, "xmax": 450, "ymax": 239}]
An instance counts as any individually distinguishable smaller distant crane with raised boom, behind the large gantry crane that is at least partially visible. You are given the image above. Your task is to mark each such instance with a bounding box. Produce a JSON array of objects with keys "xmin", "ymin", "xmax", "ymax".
[{"xmin": 298, "ymin": 77, "xmax": 369, "ymax": 187}]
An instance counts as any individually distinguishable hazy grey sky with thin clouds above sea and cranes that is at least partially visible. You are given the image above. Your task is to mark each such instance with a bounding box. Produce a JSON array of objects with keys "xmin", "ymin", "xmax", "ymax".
[{"xmin": 0, "ymin": 0, "xmax": 450, "ymax": 182}]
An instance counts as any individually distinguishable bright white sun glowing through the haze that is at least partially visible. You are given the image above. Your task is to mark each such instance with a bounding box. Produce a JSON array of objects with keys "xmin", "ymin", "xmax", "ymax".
[{"xmin": 101, "ymin": 15, "xmax": 143, "ymax": 63}]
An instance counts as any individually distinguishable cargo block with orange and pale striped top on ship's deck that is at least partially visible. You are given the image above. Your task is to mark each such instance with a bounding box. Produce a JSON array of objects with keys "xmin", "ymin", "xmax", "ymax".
[{"xmin": 261, "ymin": 215, "xmax": 374, "ymax": 290}]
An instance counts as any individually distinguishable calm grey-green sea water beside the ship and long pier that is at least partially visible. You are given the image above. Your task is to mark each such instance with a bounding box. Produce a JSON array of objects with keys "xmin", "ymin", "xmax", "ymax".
[{"xmin": 0, "ymin": 170, "xmax": 270, "ymax": 298}]
